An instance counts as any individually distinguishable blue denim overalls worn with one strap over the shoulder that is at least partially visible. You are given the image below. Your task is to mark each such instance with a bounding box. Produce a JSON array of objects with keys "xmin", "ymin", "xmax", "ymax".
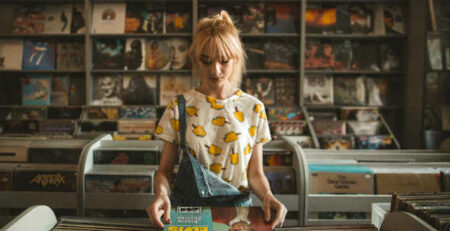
[{"xmin": 170, "ymin": 95, "xmax": 252, "ymax": 207}]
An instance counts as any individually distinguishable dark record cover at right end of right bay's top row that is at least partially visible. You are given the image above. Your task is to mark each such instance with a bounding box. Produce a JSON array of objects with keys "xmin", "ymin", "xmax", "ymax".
[{"xmin": 383, "ymin": 4, "xmax": 406, "ymax": 34}]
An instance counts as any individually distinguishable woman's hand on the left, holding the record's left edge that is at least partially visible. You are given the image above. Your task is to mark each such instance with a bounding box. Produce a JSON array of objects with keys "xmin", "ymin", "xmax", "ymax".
[{"xmin": 147, "ymin": 195, "xmax": 171, "ymax": 228}]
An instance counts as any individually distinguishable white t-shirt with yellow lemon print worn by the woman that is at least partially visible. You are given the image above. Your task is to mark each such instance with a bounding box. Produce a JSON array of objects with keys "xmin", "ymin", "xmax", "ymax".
[{"xmin": 155, "ymin": 89, "xmax": 271, "ymax": 191}]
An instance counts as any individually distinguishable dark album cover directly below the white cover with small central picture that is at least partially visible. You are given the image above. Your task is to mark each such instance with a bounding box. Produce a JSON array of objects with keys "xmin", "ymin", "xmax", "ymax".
[{"xmin": 92, "ymin": 38, "xmax": 125, "ymax": 70}]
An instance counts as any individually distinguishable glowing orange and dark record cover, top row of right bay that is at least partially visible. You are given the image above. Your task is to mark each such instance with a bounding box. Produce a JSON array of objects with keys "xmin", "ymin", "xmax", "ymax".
[{"xmin": 305, "ymin": 6, "xmax": 337, "ymax": 34}]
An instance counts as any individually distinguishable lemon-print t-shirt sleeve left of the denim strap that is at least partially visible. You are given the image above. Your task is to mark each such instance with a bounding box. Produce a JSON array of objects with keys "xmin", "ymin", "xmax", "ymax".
[{"xmin": 155, "ymin": 98, "xmax": 180, "ymax": 144}]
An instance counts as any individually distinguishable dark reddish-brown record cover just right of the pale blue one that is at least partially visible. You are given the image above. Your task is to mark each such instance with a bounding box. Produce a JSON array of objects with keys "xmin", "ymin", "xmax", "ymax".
[{"xmin": 51, "ymin": 75, "xmax": 70, "ymax": 106}]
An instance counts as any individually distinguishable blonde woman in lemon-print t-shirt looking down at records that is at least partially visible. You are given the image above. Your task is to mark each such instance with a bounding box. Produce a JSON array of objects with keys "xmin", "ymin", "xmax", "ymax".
[{"xmin": 147, "ymin": 11, "xmax": 287, "ymax": 228}]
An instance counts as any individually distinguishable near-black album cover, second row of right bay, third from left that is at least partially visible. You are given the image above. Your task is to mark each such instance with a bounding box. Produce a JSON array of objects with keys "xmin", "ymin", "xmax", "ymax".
[{"xmin": 351, "ymin": 41, "xmax": 381, "ymax": 71}]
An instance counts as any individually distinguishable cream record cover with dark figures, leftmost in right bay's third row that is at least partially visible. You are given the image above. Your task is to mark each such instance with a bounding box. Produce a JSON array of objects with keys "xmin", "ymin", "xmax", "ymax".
[{"xmin": 303, "ymin": 75, "xmax": 334, "ymax": 105}]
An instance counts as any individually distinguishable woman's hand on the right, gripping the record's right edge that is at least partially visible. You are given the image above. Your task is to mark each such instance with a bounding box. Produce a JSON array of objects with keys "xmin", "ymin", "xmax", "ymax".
[{"xmin": 263, "ymin": 193, "xmax": 287, "ymax": 229}]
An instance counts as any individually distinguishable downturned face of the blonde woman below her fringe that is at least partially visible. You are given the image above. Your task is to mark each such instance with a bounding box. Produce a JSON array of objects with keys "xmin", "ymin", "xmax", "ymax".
[{"xmin": 199, "ymin": 55, "xmax": 234, "ymax": 87}]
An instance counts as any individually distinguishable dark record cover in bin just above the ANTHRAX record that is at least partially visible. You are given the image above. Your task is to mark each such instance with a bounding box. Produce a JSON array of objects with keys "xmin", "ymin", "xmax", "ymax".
[{"xmin": 28, "ymin": 148, "xmax": 82, "ymax": 164}]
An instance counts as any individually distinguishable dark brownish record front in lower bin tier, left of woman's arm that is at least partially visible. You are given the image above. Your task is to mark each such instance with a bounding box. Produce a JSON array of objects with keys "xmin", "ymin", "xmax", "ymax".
[{"xmin": 85, "ymin": 174, "xmax": 153, "ymax": 193}]
